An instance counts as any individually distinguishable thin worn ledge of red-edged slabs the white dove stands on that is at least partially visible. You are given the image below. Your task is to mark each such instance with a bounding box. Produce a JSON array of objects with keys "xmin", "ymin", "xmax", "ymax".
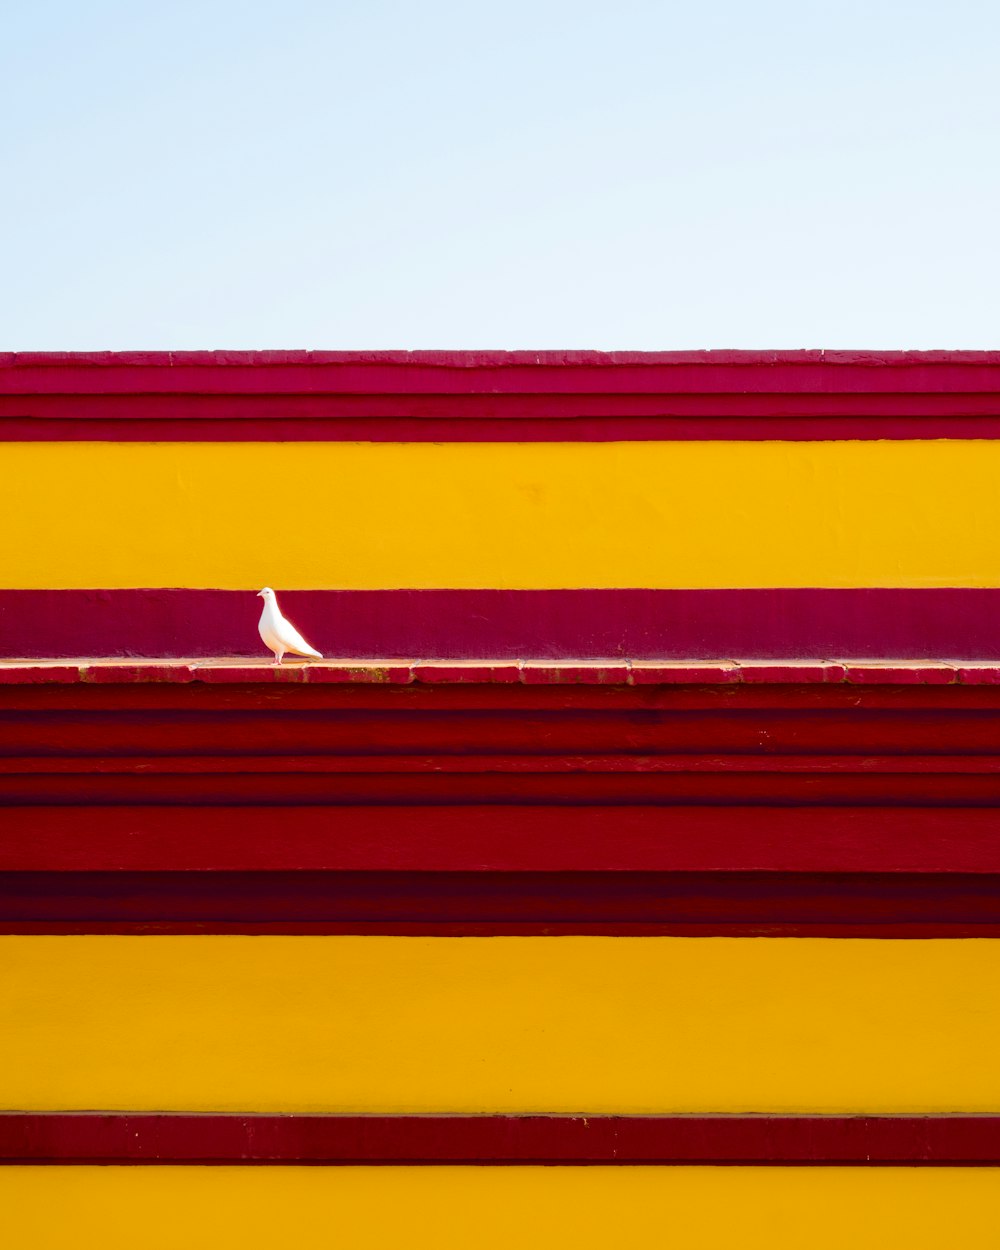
[{"xmin": 0, "ymin": 656, "xmax": 1000, "ymax": 686}]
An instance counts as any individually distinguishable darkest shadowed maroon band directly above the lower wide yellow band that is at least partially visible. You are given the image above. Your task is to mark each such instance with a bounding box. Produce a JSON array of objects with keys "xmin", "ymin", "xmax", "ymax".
[{"xmin": 0, "ymin": 871, "xmax": 1000, "ymax": 938}]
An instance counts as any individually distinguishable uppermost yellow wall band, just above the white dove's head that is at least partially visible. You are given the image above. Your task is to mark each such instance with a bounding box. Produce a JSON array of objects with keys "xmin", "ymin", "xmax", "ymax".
[{"xmin": 0, "ymin": 440, "xmax": 1000, "ymax": 590}]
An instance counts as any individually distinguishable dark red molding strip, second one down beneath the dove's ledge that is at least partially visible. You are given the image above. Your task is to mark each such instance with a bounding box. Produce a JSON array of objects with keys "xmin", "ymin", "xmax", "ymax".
[{"xmin": 0, "ymin": 700, "xmax": 1000, "ymax": 755}]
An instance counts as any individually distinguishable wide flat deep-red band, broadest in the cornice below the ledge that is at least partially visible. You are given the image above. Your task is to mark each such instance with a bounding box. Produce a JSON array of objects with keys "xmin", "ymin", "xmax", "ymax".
[{"xmin": 7, "ymin": 805, "xmax": 1000, "ymax": 874}]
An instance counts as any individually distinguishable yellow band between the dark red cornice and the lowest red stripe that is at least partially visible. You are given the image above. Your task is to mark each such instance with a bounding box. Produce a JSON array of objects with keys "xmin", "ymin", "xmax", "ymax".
[{"xmin": 7, "ymin": 940, "xmax": 1000, "ymax": 1113}]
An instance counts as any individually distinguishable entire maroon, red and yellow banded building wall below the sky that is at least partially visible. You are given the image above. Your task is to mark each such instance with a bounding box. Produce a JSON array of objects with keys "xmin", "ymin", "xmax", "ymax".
[{"xmin": 0, "ymin": 353, "xmax": 1000, "ymax": 1250}]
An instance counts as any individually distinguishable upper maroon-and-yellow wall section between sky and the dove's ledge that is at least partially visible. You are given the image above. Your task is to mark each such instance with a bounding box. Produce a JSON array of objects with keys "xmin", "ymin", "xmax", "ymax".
[{"xmin": 0, "ymin": 353, "xmax": 1000, "ymax": 659}]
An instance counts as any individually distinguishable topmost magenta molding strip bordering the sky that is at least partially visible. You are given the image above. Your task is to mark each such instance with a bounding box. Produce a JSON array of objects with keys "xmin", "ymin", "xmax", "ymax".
[{"xmin": 0, "ymin": 351, "xmax": 1000, "ymax": 395}]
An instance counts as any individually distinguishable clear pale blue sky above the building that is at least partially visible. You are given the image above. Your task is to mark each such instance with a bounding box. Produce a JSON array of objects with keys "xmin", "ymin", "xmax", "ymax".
[{"xmin": 0, "ymin": 0, "xmax": 1000, "ymax": 350}]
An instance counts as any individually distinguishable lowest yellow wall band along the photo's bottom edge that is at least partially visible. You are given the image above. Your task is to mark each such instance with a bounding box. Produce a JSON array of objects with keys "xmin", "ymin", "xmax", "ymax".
[{"xmin": 0, "ymin": 1168, "xmax": 1000, "ymax": 1250}]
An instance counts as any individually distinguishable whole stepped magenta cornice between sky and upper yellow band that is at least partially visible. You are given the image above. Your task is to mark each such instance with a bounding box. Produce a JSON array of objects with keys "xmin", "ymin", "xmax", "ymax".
[{"xmin": 0, "ymin": 351, "xmax": 1000, "ymax": 441}]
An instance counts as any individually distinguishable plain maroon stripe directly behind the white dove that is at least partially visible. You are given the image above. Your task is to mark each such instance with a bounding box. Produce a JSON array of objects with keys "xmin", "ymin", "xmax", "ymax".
[{"xmin": 9, "ymin": 588, "xmax": 1000, "ymax": 660}]
